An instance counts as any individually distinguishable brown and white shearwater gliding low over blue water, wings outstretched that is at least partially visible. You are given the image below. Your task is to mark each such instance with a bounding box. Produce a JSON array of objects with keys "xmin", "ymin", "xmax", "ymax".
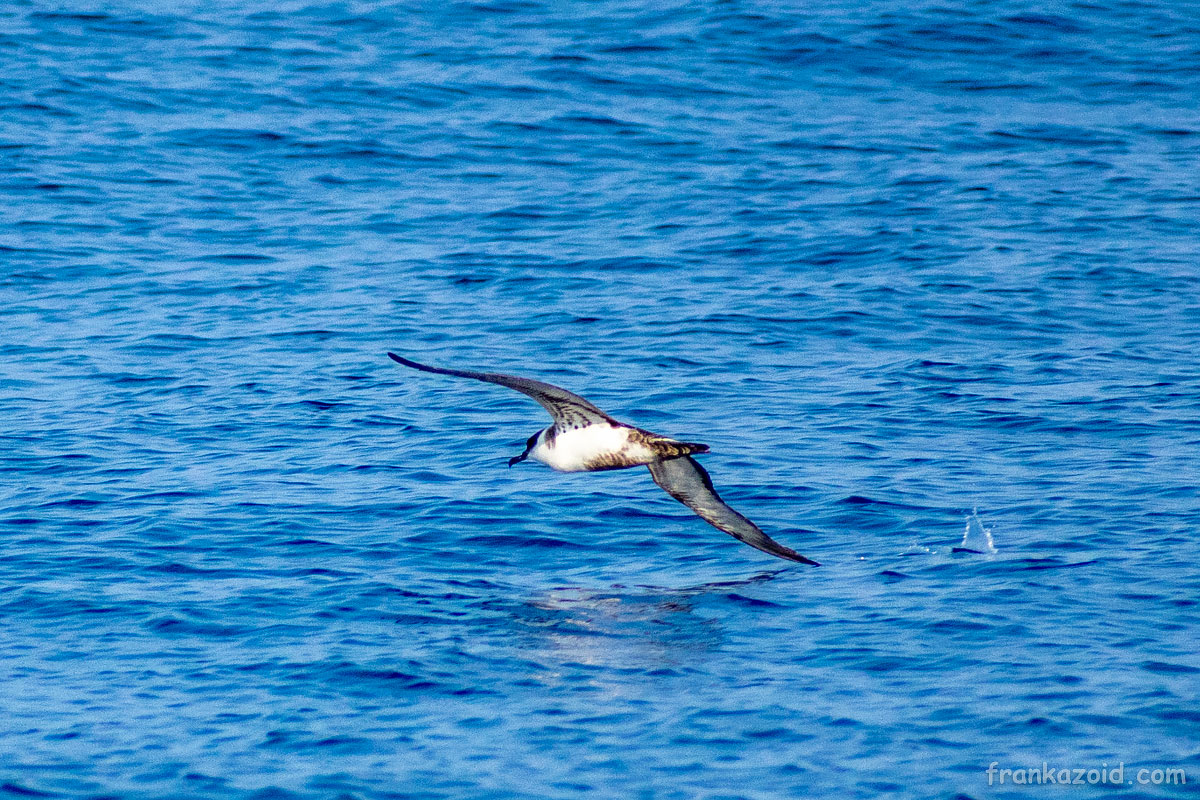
[{"xmin": 388, "ymin": 353, "xmax": 820, "ymax": 566}]
